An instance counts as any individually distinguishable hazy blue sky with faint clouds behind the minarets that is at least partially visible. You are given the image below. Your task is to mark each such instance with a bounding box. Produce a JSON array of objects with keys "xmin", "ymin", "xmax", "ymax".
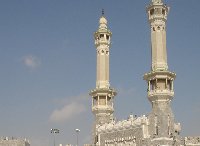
[{"xmin": 0, "ymin": 0, "xmax": 200, "ymax": 146}]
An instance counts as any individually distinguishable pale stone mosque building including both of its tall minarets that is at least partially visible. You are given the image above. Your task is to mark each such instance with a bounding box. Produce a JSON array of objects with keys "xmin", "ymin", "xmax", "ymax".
[{"xmin": 90, "ymin": 0, "xmax": 200, "ymax": 146}]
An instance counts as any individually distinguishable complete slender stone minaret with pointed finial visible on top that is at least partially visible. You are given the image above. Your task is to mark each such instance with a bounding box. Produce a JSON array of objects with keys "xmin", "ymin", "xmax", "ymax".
[{"xmin": 90, "ymin": 11, "xmax": 116, "ymax": 144}]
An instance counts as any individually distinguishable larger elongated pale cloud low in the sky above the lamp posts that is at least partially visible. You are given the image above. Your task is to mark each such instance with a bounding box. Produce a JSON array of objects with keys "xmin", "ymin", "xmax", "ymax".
[{"xmin": 50, "ymin": 102, "xmax": 86, "ymax": 123}]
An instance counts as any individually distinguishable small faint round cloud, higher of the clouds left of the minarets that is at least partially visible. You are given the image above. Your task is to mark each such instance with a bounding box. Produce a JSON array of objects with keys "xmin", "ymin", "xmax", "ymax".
[{"xmin": 23, "ymin": 55, "xmax": 41, "ymax": 69}]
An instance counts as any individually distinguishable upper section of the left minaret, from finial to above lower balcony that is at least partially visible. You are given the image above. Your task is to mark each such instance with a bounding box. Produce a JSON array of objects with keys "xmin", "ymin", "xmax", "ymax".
[{"xmin": 94, "ymin": 12, "xmax": 109, "ymax": 88}]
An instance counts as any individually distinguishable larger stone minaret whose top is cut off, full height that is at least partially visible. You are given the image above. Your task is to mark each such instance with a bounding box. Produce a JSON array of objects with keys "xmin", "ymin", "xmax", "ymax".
[{"xmin": 144, "ymin": 0, "xmax": 179, "ymax": 145}]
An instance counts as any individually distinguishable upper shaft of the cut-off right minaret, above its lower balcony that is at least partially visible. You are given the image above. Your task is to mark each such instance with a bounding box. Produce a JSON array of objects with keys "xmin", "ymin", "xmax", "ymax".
[{"xmin": 147, "ymin": 0, "xmax": 169, "ymax": 71}]
